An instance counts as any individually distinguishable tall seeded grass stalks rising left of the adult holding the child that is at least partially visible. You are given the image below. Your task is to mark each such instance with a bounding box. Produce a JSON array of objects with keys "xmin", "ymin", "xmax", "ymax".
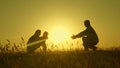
[{"xmin": 0, "ymin": 37, "xmax": 26, "ymax": 53}]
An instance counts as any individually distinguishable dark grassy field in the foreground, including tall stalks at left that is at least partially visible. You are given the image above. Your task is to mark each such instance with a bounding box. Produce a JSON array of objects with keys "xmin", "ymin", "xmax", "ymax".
[{"xmin": 0, "ymin": 38, "xmax": 120, "ymax": 68}]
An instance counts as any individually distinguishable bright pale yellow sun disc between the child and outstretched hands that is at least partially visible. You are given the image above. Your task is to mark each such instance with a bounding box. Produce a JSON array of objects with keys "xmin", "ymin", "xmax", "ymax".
[{"xmin": 50, "ymin": 27, "xmax": 69, "ymax": 44}]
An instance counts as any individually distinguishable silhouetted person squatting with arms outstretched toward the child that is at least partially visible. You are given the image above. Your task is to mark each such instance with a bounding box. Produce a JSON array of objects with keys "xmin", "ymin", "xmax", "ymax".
[{"xmin": 72, "ymin": 20, "xmax": 99, "ymax": 51}]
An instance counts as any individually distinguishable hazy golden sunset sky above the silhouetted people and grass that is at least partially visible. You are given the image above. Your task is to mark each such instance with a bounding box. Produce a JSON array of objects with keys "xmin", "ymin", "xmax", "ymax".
[{"xmin": 0, "ymin": 0, "xmax": 120, "ymax": 47}]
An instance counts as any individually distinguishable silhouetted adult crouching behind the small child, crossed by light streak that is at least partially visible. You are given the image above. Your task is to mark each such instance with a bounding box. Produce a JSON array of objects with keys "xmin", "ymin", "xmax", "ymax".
[{"xmin": 27, "ymin": 29, "xmax": 41, "ymax": 52}]
